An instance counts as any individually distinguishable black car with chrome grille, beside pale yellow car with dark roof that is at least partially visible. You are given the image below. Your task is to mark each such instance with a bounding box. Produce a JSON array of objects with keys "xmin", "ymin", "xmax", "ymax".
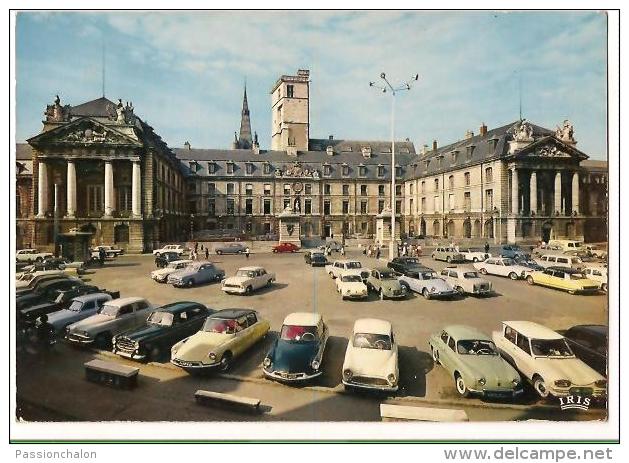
[{"xmin": 113, "ymin": 301, "xmax": 214, "ymax": 360}]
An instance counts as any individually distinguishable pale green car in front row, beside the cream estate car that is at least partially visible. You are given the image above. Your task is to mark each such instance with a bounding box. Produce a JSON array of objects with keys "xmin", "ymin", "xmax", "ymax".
[{"xmin": 428, "ymin": 325, "xmax": 524, "ymax": 399}]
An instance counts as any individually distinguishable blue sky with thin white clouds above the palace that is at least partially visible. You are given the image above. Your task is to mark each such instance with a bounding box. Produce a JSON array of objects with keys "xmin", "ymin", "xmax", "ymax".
[{"xmin": 15, "ymin": 11, "xmax": 607, "ymax": 159}]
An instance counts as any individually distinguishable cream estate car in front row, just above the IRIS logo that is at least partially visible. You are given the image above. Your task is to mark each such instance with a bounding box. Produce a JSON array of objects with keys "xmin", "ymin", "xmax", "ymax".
[{"xmin": 492, "ymin": 321, "xmax": 607, "ymax": 398}]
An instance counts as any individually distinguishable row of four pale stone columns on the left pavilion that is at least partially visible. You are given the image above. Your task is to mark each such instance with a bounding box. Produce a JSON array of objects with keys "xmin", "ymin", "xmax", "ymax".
[{"xmin": 37, "ymin": 160, "xmax": 142, "ymax": 218}]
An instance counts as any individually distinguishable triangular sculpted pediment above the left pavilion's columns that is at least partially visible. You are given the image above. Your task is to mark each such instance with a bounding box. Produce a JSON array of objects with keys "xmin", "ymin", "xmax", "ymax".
[{"xmin": 28, "ymin": 117, "xmax": 141, "ymax": 146}]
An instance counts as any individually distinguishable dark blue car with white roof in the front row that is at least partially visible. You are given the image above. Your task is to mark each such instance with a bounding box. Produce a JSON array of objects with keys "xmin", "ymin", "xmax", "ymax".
[{"xmin": 262, "ymin": 312, "xmax": 329, "ymax": 382}]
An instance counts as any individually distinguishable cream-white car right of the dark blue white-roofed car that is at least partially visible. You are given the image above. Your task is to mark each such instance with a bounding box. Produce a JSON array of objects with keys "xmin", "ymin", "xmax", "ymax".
[{"xmin": 343, "ymin": 318, "xmax": 400, "ymax": 391}]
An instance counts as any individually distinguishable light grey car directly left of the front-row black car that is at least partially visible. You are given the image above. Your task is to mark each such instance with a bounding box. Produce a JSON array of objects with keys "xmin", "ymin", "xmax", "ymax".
[{"xmin": 65, "ymin": 297, "xmax": 153, "ymax": 347}]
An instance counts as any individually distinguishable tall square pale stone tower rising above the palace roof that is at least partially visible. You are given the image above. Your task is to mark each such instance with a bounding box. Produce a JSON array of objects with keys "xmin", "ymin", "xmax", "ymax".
[{"xmin": 271, "ymin": 69, "xmax": 310, "ymax": 155}]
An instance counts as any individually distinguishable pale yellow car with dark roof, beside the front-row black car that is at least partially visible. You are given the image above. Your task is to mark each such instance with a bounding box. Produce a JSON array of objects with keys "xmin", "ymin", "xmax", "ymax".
[{"xmin": 170, "ymin": 309, "xmax": 270, "ymax": 373}]
